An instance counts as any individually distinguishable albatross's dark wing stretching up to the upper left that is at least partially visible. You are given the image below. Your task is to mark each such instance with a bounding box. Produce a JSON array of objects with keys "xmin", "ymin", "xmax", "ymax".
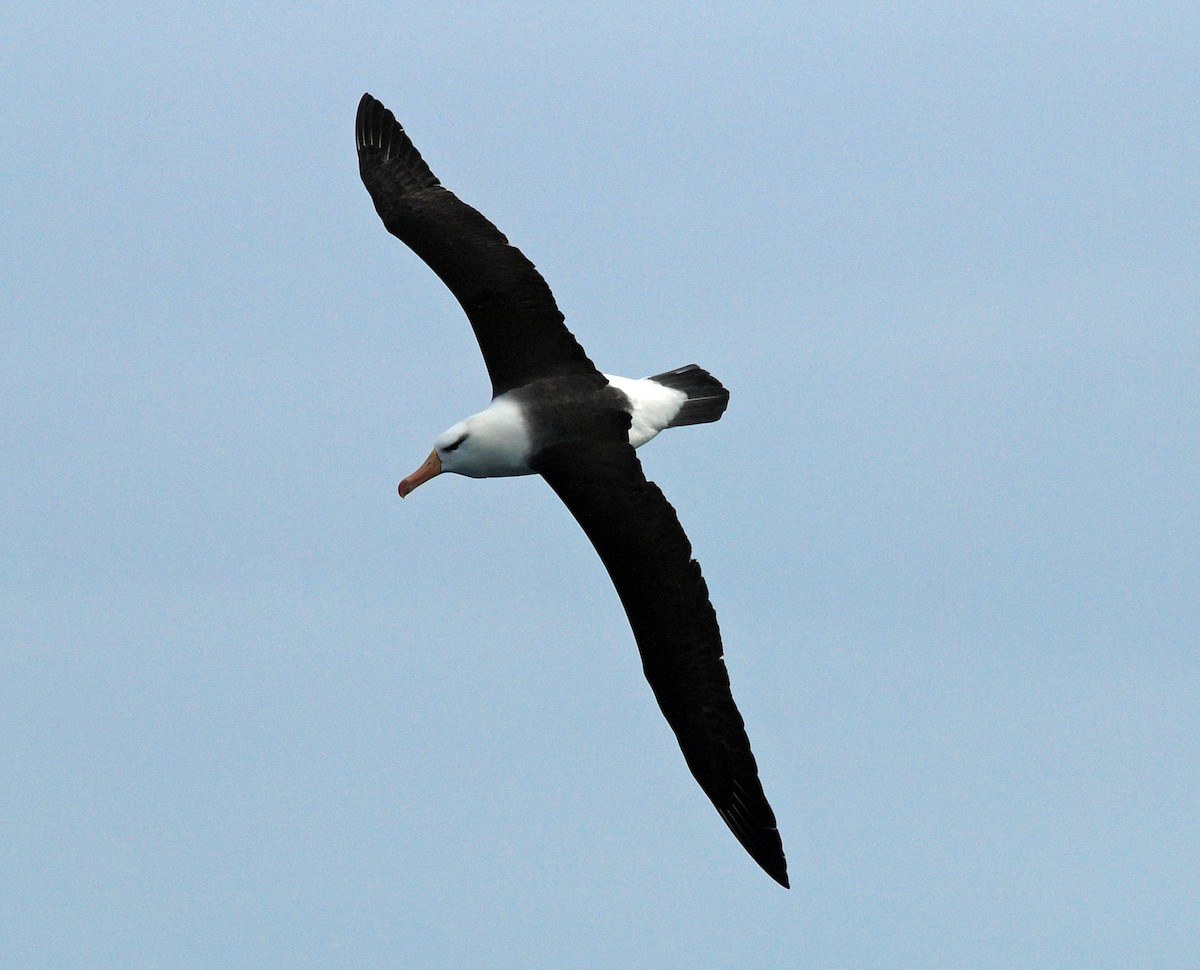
[{"xmin": 355, "ymin": 95, "xmax": 599, "ymax": 394}]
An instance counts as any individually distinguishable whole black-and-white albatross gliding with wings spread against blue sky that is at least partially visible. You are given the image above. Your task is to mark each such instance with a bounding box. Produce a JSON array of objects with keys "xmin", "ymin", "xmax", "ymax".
[{"xmin": 355, "ymin": 95, "xmax": 787, "ymax": 886}]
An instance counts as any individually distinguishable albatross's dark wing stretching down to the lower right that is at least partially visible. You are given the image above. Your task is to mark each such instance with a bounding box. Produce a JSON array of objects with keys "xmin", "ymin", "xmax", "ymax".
[{"xmin": 532, "ymin": 432, "xmax": 787, "ymax": 886}]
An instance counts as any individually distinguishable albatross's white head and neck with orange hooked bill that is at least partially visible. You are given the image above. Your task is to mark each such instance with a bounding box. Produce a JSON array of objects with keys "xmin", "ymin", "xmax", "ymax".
[{"xmin": 400, "ymin": 397, "xmax": 533, "ymax": 498}]
